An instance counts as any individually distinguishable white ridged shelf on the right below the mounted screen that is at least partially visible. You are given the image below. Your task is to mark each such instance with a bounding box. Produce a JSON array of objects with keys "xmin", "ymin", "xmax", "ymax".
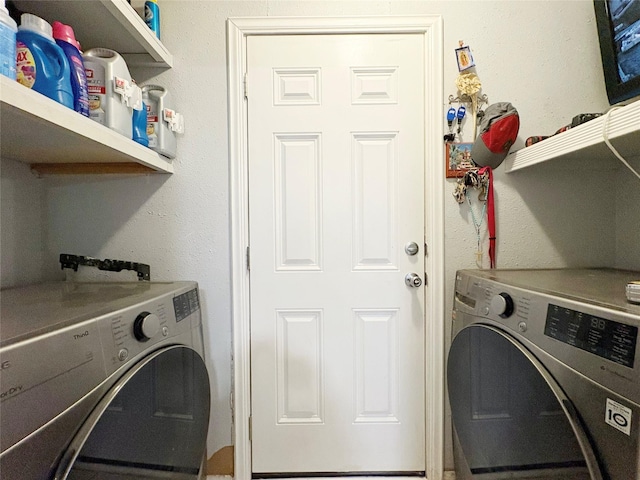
[{"xmin": 505, "ymin": 101, "xmax": 640, "ymax": 173}]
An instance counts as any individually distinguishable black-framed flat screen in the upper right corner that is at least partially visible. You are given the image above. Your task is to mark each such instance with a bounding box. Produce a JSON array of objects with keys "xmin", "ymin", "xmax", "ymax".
[{"xmin": 593, "ymin": 0, "xmax": 640, "ymax": 105}]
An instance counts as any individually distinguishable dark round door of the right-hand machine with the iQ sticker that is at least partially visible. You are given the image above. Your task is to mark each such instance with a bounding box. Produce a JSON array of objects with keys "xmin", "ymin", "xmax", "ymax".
[{"xmin": 447, "ymin": 324, "xmax": 602, "ymax": 480}]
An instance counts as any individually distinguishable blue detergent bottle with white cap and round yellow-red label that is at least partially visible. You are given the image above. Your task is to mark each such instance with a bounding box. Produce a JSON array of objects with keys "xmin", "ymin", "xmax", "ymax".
[{"xmin": 16, "ymin": 13, "xmax": 73, "ymax": 109}]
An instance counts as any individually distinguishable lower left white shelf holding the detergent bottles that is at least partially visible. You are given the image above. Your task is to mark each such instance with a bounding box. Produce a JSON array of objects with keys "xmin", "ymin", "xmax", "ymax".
[{"xmin": 0, "ymin": 75, "xmax": 173, "ymax": 174}]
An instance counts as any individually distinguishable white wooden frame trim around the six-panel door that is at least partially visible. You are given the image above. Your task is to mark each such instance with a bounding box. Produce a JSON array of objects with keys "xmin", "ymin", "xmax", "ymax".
[{"xmin": 227, "ymin": 15, "xmax": 445, "ymax": 480}]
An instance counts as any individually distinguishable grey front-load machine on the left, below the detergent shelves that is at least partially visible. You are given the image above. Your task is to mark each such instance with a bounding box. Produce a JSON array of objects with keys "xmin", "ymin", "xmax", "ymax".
[{"xmin": 0, "ymin": 282, "xmax": 210, "ymax": 480}]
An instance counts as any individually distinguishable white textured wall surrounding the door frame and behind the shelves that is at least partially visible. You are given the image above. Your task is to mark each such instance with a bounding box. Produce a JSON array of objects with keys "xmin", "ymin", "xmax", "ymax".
[{"xmin": 2, "ymin": 0, "xmax": 640, "ymax": 472}]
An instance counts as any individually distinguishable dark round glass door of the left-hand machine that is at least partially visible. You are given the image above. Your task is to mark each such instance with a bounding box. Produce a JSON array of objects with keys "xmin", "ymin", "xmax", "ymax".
[{"xmin": 54, "ymin": 346, "xmax": 210, "ymax": 479}]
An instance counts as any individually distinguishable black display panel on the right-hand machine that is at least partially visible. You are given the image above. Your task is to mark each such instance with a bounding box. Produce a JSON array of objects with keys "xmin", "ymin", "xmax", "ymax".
[{"xmin": 544, "ymin": 304, "xmax": 638, "ymax": 368}]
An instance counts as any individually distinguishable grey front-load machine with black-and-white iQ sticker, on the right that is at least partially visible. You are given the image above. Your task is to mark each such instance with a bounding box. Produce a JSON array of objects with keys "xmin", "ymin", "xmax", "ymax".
[{"xmin": 447, "ymin": 269, "xmax": 640, "ymax": 480}]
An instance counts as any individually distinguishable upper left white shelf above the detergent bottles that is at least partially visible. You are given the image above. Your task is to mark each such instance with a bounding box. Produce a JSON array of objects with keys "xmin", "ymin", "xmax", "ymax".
[{"xmin": 14, "ymin": 0, "xmax": 173, "ymax": 68}]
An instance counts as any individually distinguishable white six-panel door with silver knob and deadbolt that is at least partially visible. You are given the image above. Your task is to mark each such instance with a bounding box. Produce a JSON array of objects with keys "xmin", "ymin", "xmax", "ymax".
[{"xmin": 247, "ymin": 34, "xmax": 425, "ymax": 473}]
